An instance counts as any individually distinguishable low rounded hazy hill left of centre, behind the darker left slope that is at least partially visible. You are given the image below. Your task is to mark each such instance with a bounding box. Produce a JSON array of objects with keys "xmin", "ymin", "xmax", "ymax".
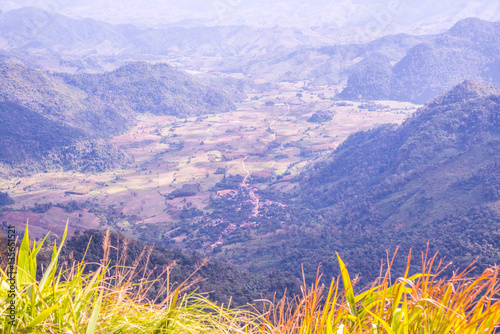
[{"xmin": 61, "ymin": 62, "xmax": 235, "ymax": 117}]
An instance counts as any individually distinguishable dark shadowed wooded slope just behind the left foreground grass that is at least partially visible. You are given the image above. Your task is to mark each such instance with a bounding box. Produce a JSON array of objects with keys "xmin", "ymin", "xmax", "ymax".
[{"xmin": 41, "ymin": 230, "xmax": 300, "ymax": 305}]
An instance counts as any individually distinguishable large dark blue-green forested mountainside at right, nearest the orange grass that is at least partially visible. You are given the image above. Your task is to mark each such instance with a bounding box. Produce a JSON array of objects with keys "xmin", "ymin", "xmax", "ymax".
[{"xmin": 220, "ymin": 80, "xmax": 500, "ymax": 283}]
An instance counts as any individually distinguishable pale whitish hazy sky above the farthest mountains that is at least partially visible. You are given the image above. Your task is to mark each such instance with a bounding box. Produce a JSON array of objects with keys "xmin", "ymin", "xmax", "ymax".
[{"xmin": 0, "ymin": 0, "xmax": 500, "ymax": 30}]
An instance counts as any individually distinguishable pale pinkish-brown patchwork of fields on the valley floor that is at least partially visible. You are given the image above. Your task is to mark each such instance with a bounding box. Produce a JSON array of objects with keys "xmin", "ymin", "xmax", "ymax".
[{"xmin": 0, "ymin": 83, "xmax": 418, "ymax": 239}]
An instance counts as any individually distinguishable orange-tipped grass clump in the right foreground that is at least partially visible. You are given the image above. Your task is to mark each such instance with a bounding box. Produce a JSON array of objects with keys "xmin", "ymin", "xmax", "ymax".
[{"xmin": 260, "ymin": 252, "xmax": 500, "ymax": 334}]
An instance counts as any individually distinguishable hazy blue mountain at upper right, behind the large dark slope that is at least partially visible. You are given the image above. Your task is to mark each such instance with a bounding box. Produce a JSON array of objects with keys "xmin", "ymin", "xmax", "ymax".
[{"xmin": 338, "ymin": 18, "xmax": 500, "ymax": 103}]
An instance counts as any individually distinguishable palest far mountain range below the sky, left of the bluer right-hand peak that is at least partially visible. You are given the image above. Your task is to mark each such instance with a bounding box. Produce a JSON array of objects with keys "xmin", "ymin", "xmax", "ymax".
[{"xmin": 0, "ymin": 7, "xmax": 427, "ymax": 85}]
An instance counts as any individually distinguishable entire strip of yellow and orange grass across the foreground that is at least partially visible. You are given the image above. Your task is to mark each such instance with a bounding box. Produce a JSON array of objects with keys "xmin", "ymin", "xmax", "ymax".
[{"xmin": 0, "ymin": 223, "xmax": 500, "ymax": 334}]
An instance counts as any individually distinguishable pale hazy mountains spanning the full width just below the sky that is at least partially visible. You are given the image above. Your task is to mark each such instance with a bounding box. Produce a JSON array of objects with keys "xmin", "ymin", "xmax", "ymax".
[{"xmin": 0, "ymin": 8, "xmax": 500, "ymax": 103}]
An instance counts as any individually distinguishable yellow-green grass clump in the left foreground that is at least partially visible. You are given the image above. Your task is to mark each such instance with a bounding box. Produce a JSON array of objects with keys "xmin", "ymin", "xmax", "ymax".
[{"xmin": 0, "ymin": 223, "xmax": 253, "ymax": 334}]
